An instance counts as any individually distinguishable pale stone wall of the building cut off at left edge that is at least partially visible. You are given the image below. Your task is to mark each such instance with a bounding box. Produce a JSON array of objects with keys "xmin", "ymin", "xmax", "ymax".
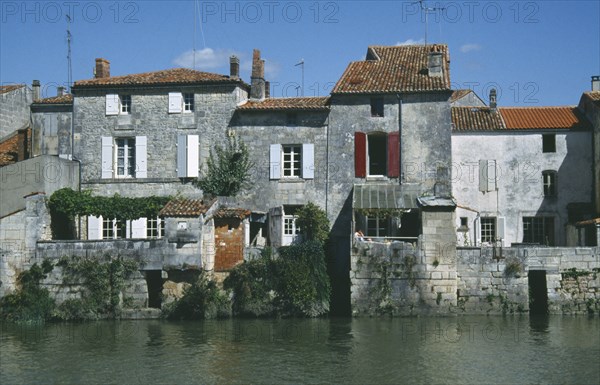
[{"xmin": 0, "ymin": 85, "xmax": 33, "ymax": 138}]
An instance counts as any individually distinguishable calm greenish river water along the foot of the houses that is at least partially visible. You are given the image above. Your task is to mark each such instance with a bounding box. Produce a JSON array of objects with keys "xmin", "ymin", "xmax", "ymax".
[{"xmin": 0, "ymin": 316, "xmax": 600, "ymax": 384}]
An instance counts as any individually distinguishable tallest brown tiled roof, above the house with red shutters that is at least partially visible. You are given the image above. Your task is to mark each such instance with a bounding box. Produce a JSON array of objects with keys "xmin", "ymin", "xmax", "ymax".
[{"xmin": 332, "ymin": 44, "xmax": 450, "ymax": 94}]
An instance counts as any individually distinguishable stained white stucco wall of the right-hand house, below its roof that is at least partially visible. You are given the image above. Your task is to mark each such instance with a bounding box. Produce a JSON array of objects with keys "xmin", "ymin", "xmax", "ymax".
[{"xmin": 452, "ymin": 130, "xmax": 593, "ymax": 246}]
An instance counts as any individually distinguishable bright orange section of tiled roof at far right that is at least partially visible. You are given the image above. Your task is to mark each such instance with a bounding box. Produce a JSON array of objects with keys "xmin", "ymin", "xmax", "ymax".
[{"xmin": 499, "ymin": 107, "xmax": 590, "ymax": 130}]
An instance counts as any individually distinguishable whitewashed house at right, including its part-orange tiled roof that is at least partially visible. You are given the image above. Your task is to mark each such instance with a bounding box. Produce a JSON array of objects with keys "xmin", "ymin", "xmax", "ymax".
[{"xmin": 452, "ymin": 96, "xmax": 593, "ymax": 247}]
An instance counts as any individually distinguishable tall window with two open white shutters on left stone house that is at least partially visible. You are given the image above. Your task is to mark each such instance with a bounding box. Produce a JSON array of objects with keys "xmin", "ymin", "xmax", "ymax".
[{"xmin": 101, "ymin": 136, "xmax": 148, "ymax": 179}]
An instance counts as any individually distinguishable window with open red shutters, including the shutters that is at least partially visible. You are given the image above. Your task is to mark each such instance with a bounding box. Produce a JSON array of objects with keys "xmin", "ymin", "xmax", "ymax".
[{"xmin": 354, "ymin": 132, "xmax": 400, "ymax": 178}]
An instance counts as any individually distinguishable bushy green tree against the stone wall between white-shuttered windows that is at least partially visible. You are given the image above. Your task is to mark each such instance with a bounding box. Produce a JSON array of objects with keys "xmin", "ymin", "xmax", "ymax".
[{"xmin": 197, "ymin": 137, "xmax": 254, "ymax": 196}]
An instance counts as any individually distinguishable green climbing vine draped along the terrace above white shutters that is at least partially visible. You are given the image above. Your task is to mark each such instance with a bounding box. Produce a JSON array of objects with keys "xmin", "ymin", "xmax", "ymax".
[{"xmin": 48, "ymin": 187, "xmax": 171, "ymax": 239}]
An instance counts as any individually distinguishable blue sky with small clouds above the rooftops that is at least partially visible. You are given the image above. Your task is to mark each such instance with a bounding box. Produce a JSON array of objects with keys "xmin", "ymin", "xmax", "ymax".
[{"xmin": 0, "ymin": 0, "xmax": 600, "ymax": 106}]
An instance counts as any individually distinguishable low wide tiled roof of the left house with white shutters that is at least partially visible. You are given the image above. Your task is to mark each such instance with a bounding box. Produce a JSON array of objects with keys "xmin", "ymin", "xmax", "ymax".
[{"xmin": 73, "ymin": 68, "xmax": 242, "ymax": 88}]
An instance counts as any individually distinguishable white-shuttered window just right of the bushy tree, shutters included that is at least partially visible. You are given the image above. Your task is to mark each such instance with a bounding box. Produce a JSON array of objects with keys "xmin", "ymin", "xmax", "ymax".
[{"xmin": 269, "ymin": 143, "xmax": 315, "ymax": 179}]
